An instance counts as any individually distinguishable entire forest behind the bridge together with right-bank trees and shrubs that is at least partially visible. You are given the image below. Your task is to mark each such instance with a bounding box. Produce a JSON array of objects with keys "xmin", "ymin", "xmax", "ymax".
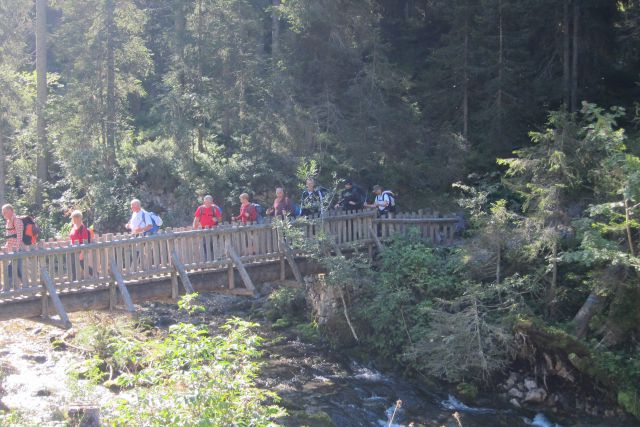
[{"xmin": 0, "ymin": 0, "xmax": 640, "ymax": 418}]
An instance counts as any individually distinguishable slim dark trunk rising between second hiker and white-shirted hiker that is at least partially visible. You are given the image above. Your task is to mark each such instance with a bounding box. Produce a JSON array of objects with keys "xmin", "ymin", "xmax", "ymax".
[{"xmin": 104, "ymin": 0, "xmax": 116, "ymax": 169}]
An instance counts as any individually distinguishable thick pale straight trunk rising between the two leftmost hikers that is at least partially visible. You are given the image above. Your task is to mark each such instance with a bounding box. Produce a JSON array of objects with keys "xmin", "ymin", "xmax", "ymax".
[{"xmin": 34, "ymin": 0, "xmax": 49, "ymax": 206}]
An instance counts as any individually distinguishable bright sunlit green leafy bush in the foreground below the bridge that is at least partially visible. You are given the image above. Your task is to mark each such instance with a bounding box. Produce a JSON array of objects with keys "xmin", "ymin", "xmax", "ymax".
[{"xmin": 67, "ymin": 297, "xmax": 284, "ymax": 426}]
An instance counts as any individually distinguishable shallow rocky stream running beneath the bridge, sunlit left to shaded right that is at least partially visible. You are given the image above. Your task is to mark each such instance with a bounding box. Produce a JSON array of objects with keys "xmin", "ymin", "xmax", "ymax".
[{"xmin": 0, "ymin": 294, "xmax": 640, "ymax": 427}]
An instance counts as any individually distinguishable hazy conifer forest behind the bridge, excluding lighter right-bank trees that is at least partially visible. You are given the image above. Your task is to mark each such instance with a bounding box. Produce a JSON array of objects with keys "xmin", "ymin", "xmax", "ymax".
[{"xmin": 0, "ymin": 0, "xmax": 640, "ymax": 231}]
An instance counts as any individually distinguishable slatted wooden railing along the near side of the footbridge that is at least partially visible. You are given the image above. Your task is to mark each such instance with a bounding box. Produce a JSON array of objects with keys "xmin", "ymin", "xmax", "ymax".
[{"xmin": 0, "ymin": 211, "xmax": 456, "ymax": 301}]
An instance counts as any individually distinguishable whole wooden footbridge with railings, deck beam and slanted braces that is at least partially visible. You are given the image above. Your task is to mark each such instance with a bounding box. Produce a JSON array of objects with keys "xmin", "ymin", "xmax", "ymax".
[{"xmin": 0, "ymin": 212, "xmax": 458, "ymax": 327}]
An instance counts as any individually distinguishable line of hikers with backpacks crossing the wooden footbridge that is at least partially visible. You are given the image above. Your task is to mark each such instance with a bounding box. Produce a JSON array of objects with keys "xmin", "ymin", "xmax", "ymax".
[{"xmin": 1, "ymin": 178, "xmax": 395, "ymax": 252}]
